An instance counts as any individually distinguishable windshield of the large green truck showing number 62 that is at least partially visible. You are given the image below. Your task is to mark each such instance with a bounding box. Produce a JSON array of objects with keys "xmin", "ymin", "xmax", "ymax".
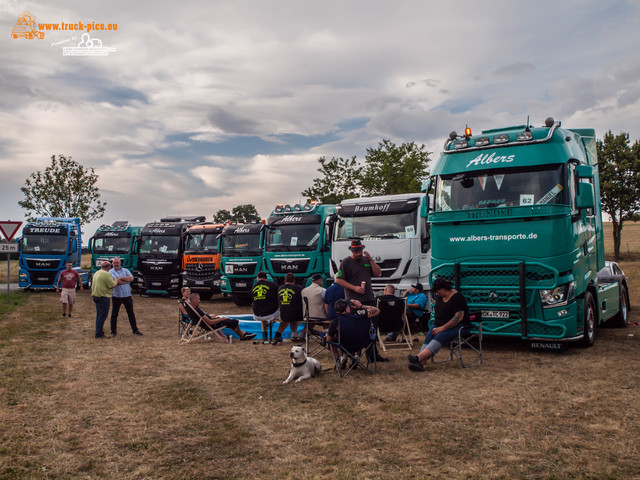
[{"xmin": 436, "ymin": 165, "xmax": 566, "ymax": 211}]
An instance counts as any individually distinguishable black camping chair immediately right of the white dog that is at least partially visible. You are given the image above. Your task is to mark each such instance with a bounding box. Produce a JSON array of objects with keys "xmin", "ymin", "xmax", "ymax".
[{"xmin": 327, "ymin": 315, "xmax": 376, "ymax": 378}]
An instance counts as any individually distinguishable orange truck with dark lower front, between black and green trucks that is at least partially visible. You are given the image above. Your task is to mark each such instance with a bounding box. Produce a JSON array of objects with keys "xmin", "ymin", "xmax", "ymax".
[{"xmin": 182, "ymin": 222, "xmax": 225, "ymax": 300}]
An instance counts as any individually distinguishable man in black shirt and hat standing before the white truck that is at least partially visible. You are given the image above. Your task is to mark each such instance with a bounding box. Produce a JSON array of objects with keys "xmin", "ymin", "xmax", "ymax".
[{"xmin": 336, "ymin": 240, "xmax": 382, "ymax": 305}]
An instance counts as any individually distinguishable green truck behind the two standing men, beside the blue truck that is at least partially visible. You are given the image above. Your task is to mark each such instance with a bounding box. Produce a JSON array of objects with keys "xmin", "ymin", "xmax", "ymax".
[{"xmin": 89, "ymin": 220, "xmax": 142, "ymax": 288}]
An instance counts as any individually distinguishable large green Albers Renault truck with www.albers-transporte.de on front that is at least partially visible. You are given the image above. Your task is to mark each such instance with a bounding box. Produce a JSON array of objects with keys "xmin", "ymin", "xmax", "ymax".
[{"xmin": 428, "ymin": 118, "xmax": 629, "ymax": 348}]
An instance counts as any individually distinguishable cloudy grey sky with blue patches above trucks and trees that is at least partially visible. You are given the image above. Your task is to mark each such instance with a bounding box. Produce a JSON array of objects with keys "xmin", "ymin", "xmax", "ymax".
[{"xmin": 0, "ymin": 0, "xmax": 640, "ymax": 242}]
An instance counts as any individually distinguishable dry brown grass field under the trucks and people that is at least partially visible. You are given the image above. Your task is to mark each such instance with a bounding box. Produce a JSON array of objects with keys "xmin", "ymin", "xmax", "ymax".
[{"xmin": 0, "ymin": 223, "xmax": 640, "ymax": 479}]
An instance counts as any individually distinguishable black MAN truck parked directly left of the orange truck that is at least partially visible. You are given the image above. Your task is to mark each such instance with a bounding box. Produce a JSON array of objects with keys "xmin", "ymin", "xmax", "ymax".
[{"xmin": 137, "ymin": 216, "xmax": 206, "ymax": 296}]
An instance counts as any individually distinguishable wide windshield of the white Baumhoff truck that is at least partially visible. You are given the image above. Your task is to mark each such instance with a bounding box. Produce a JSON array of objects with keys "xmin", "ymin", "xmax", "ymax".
[{"xmin": 335, "ymin": 210, "xmax": 417, "ymax": 240}]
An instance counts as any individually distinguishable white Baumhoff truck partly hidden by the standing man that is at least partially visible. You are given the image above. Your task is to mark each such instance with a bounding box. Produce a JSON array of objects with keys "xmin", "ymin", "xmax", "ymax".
[{"xmin": 331, "ymin": 193, "xmax": 430, "ymax": 292}]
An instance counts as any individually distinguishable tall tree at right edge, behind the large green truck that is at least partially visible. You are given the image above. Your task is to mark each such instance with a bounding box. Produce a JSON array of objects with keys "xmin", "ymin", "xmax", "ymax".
[{"xmin": 596, "ymin": 130, "xmax": 640, "ymax": 261}]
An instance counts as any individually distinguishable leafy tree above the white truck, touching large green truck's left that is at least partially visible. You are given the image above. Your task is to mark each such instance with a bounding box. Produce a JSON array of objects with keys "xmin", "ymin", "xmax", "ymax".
[{"xmin": 360, "ymin": 140, "xmax": 431, "ymax": 196}]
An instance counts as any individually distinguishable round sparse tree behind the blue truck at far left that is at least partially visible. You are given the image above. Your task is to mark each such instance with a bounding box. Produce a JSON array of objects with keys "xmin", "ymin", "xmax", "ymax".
[{"xmin": 18, "ymin": 155, "xmax": 107, "ymax": 224}]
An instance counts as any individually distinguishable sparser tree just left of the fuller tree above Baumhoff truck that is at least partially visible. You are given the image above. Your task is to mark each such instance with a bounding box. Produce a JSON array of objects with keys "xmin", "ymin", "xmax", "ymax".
[{"xmin": 302, "ymin": 156, "xmax": 361, "ymax": 204}]
